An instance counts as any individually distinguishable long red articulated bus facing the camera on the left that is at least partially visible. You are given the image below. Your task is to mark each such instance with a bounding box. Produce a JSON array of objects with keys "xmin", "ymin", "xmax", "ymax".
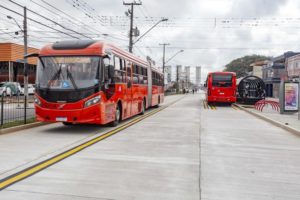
[{"xmin": 26, "ymin": 40, "xmax": 164, "ymax": 126}]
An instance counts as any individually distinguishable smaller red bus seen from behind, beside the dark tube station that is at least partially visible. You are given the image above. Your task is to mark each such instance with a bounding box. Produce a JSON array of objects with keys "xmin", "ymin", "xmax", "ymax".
[{"xmin": 206, "ymin": 72, "xmax": 236, "ymax": 103}]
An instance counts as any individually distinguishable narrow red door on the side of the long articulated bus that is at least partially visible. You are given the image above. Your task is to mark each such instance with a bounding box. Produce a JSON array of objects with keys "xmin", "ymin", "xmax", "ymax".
[{"xmin": 125, "ymin": 62, "xmax": 133, "ymax": 118}]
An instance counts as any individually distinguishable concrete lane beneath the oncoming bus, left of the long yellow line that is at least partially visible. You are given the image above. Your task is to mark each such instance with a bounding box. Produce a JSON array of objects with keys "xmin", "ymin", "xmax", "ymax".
[{"xmin": 0, "ymin": 95, "xmax": 181, "ymax": 179}]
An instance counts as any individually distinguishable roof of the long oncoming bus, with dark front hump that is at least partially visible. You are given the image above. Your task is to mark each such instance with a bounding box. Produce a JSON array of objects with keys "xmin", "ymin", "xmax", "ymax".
[{"xmin": 39, "ymin": 40, "xmax": 161, "ymax": 73}]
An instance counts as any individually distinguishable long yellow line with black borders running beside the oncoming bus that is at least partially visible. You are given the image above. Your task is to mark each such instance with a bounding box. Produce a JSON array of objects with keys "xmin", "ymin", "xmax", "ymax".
[{"xmin": 0, "ymin": 97, "xmax": 184, "ymax": 191}]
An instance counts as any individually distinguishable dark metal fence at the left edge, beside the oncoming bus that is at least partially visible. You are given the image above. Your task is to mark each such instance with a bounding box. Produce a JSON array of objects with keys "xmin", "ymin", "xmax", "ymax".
[{"xmin": 0, "ymin": 95, "xmax": 35, "ymax": 128}]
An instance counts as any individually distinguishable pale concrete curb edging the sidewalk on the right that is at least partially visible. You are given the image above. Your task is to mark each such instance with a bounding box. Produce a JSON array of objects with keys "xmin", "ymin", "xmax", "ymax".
[{"xmin": 234, "ymin": 104, "xmax": 300, "ymax": 136}]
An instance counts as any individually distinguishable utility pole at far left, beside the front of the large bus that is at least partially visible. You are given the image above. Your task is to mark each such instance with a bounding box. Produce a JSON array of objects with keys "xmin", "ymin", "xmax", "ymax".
[{"xmin": 23, "ymin": 7, "xmax": 28, "ymax": 101}]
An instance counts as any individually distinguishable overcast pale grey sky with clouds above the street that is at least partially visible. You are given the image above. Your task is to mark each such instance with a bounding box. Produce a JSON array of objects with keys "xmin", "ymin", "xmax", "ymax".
[{"xmin": 0, "ymin": 0, "xmax": 300, "ymax": 80}]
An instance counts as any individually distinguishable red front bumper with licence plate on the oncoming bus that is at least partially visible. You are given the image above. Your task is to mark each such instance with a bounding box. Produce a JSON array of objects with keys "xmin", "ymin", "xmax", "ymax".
[{"xmin": 35, "ymin": 104, "xmax": 108, "ymax": 124}]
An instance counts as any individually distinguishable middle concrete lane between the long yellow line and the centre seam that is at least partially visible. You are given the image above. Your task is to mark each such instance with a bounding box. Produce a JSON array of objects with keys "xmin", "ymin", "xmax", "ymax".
[{"xmin": 0, "ymin": 95, "xmax": 200, "ymax": 200}]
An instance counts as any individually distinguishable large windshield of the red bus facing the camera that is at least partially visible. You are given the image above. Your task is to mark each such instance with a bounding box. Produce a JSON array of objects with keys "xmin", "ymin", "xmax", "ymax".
[{"xmin": 36, "ymin": 56, "xmax": 100, "ymax": 90}]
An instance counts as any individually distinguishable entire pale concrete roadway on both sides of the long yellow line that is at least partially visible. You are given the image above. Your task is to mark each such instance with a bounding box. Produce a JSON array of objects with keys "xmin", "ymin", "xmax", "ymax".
[{"xmin": 0, "ymin": 94, "xmax": 300, "ymax": 200}]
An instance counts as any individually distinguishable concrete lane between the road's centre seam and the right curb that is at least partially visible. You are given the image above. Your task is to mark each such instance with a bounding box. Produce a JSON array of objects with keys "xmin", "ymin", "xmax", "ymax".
[{"xmin": 201, "ymin": 95, "xmax": 300, "ymax": 200}]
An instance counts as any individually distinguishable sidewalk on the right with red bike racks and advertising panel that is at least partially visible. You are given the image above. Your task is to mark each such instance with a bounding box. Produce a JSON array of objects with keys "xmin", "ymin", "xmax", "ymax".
[{"xmin": 236, "ymin": 98, "xmax": 300, "ymax": 135}]
